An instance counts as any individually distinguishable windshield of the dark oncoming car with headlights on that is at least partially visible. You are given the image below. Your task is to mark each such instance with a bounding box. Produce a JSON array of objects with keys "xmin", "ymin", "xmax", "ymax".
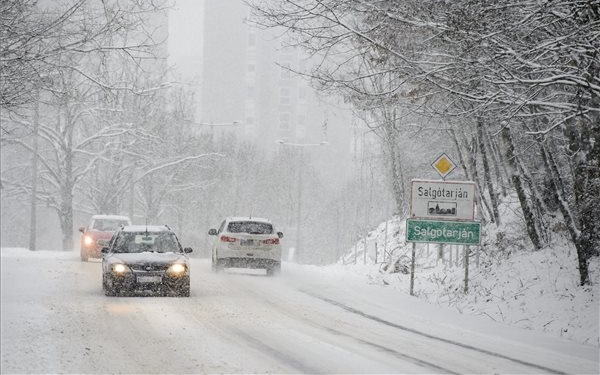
[{"xmin": 113, "ymin": 232, "xmax": 181, "ymax": 253}]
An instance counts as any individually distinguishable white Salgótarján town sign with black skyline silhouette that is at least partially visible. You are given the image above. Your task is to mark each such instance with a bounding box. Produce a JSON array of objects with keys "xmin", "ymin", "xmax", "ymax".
[{"xmin": 410, "ymin": 180, "xmax": 475, "ymax": 220}]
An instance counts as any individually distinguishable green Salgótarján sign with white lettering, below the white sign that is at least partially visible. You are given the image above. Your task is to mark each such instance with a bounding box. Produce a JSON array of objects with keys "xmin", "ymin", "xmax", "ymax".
[{"xmin": 406, "ymin": 219, "xmax": 481, "ymax": 245}]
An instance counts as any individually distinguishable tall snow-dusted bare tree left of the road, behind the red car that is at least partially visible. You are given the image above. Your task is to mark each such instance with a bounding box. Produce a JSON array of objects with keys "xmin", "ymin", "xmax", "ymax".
[{"xmin": 1, "ymin": 1, "xmax": 173, "ymax": 249}]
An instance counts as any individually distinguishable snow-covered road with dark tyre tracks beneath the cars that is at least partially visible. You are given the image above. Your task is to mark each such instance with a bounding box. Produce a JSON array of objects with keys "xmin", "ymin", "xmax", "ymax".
[{"xmin": 2, "ymin": 249, "xmax": 599, "ymax": 374}]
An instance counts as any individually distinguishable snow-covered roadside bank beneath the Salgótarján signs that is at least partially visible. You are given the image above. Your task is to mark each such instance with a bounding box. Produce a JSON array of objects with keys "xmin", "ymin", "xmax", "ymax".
[{"xmin": 338, "ymin": 206, "xmax": 600, "ymax": 346}]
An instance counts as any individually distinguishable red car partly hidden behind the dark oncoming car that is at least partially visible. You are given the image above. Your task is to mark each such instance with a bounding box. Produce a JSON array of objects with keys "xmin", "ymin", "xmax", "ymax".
[{"xmin": 79, "ymin": 215, "xmax": 131, "ymax": 262}]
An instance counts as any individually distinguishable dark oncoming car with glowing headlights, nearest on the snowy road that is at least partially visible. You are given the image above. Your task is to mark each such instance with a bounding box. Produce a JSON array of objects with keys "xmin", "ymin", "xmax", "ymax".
[{"xmin": 102, "ymin": 225, "xmax": 192, "ymax": 297}]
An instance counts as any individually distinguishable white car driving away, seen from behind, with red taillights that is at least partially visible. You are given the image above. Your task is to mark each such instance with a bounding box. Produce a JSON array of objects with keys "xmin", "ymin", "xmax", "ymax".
[{"xmin": 208, "ymin": 217, "xmax": 283, "ymax": 276}]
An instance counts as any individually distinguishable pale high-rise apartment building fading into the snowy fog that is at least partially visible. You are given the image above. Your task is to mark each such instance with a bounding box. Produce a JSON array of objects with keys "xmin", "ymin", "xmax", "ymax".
[{"xmin": 197, "ymin": 0, "xmax": 342, "ymax": 145}]
